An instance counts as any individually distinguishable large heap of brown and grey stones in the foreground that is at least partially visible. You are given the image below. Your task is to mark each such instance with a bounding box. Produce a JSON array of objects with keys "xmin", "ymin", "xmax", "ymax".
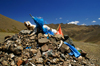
[{"xmin": 0, "ymin": 30, "xmax": 95, "ymax": 66}]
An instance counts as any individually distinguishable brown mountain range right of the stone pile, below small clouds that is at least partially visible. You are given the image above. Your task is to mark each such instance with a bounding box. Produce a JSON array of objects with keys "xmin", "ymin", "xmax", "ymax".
[{"xmin": 48, "ymin": 24, "xmax": 100, "ymax": 44}]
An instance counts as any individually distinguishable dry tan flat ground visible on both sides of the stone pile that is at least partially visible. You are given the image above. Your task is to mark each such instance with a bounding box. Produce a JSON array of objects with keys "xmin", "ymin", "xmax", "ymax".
[{"xmin": 0, "ymin": 32, "xmax": 100, "ymax": 66}]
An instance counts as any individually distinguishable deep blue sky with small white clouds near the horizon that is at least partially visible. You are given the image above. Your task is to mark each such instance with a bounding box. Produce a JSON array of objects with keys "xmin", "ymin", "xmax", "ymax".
[{"xmin": 0, "ymin": 0, "xmax": 100, "ymax": 25}]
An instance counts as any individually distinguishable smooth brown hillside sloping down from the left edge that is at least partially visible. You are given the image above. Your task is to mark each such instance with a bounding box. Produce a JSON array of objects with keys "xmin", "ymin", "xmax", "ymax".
[{"xmin": 0, "ymin": 14, "xmax": 26, "ymax": 32}]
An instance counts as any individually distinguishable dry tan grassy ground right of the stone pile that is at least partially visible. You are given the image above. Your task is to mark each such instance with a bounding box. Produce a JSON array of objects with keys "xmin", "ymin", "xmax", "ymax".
[{"xmin": 74, "ymin": 41, "xmax": 100, "ymax": 63}]
